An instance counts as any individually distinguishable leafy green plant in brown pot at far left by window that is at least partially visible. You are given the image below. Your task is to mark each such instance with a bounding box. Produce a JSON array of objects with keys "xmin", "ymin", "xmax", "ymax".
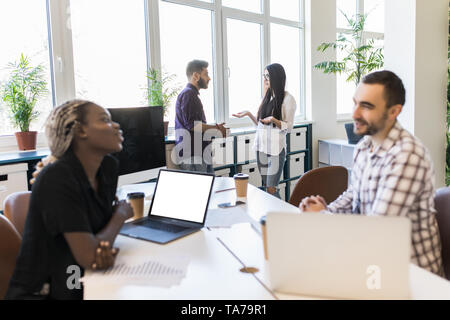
[{"xmin": 0, "ymin": 54, "xmax": 48, "ymax": 150}]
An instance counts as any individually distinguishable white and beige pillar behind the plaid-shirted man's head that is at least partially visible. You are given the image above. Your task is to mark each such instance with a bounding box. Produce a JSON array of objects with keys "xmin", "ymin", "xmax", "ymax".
[{"xmin": 385, "ymin": 0, "xmax": 448, "ymax": 187}]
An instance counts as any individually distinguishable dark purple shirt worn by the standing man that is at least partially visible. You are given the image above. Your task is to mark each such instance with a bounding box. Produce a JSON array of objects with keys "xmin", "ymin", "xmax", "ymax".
[{"xmin": 175, "ymin": 83, "xmax": 209, "ymax": 156}]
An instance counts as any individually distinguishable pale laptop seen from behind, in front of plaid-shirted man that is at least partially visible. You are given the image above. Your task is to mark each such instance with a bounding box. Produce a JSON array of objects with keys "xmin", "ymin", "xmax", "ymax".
[{"xmin": 266, "ymin": 212, "xmax": 411, "ymax": 299}]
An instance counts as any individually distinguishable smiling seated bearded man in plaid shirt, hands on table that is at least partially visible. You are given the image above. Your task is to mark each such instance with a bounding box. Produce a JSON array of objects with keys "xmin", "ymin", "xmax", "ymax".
[{"xmin": 300, "ymin": 71, "xmax": 444, "ymax": 275}]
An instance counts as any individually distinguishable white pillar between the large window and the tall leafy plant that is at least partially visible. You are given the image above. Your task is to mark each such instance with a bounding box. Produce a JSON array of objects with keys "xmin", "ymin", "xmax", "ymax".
[{"xmin": 305, "ymin": 0, "xmax": 347, "ymax": 167}]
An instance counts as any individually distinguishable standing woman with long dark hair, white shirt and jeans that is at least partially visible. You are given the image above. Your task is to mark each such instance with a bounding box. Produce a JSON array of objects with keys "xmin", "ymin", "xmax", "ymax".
[{"xmin": 233, "ymin": 63, "xmax": 296, "ymax": 198}]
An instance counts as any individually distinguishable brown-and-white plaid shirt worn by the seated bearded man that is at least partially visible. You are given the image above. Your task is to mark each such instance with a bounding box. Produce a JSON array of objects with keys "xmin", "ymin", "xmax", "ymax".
[{"xmin": 328, "ymin": 122, "xmax": 444, "ymax": 275}]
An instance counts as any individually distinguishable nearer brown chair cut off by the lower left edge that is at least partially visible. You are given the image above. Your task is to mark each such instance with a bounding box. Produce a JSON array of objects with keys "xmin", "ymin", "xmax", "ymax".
[{"xmin": 0, "ymin": 214, "xmax": 22, "ymax": 299}]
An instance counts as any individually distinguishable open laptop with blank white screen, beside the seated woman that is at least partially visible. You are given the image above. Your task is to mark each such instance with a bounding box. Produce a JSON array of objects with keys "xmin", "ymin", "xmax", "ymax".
[{"xmin": 120, "ymin": 169, "xmax": 214, "ymax": 243}]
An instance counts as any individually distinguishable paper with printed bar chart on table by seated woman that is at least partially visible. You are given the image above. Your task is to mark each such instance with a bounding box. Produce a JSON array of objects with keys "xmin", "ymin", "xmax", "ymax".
[{"xmin": 82, "ymin": 254, "xmax": 189, "ymax": 287}]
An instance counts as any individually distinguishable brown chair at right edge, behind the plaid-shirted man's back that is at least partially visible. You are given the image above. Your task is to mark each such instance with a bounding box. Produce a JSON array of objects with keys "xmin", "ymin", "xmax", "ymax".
[{"xmin": 434, "ymin": 187, "xmax": 450, "ymax": 280}]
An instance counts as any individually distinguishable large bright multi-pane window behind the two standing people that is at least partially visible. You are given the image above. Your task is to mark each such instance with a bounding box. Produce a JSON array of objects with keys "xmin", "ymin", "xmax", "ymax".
[{"xmin": 0, "ymin": 0, "xmax": 305, "ymax": 135}]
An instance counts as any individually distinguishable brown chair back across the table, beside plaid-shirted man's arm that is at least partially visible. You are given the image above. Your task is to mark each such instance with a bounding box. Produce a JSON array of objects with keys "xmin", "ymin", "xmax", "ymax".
[{"xmin": 289, "ymin": 166, "xmax": 348, "ymax": 207}]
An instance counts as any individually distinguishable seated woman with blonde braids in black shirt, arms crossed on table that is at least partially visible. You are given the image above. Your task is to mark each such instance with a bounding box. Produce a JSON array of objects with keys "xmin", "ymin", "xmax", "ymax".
[{"xmin": 6, "ymin": 100, "xmax": 133, "ymax": 299}]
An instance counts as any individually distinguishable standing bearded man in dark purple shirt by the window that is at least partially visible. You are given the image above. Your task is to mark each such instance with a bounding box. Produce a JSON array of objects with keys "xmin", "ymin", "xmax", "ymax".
[{"xmin": 175, "ymin": 60, "xmax": 226, "ymax": 173}]
